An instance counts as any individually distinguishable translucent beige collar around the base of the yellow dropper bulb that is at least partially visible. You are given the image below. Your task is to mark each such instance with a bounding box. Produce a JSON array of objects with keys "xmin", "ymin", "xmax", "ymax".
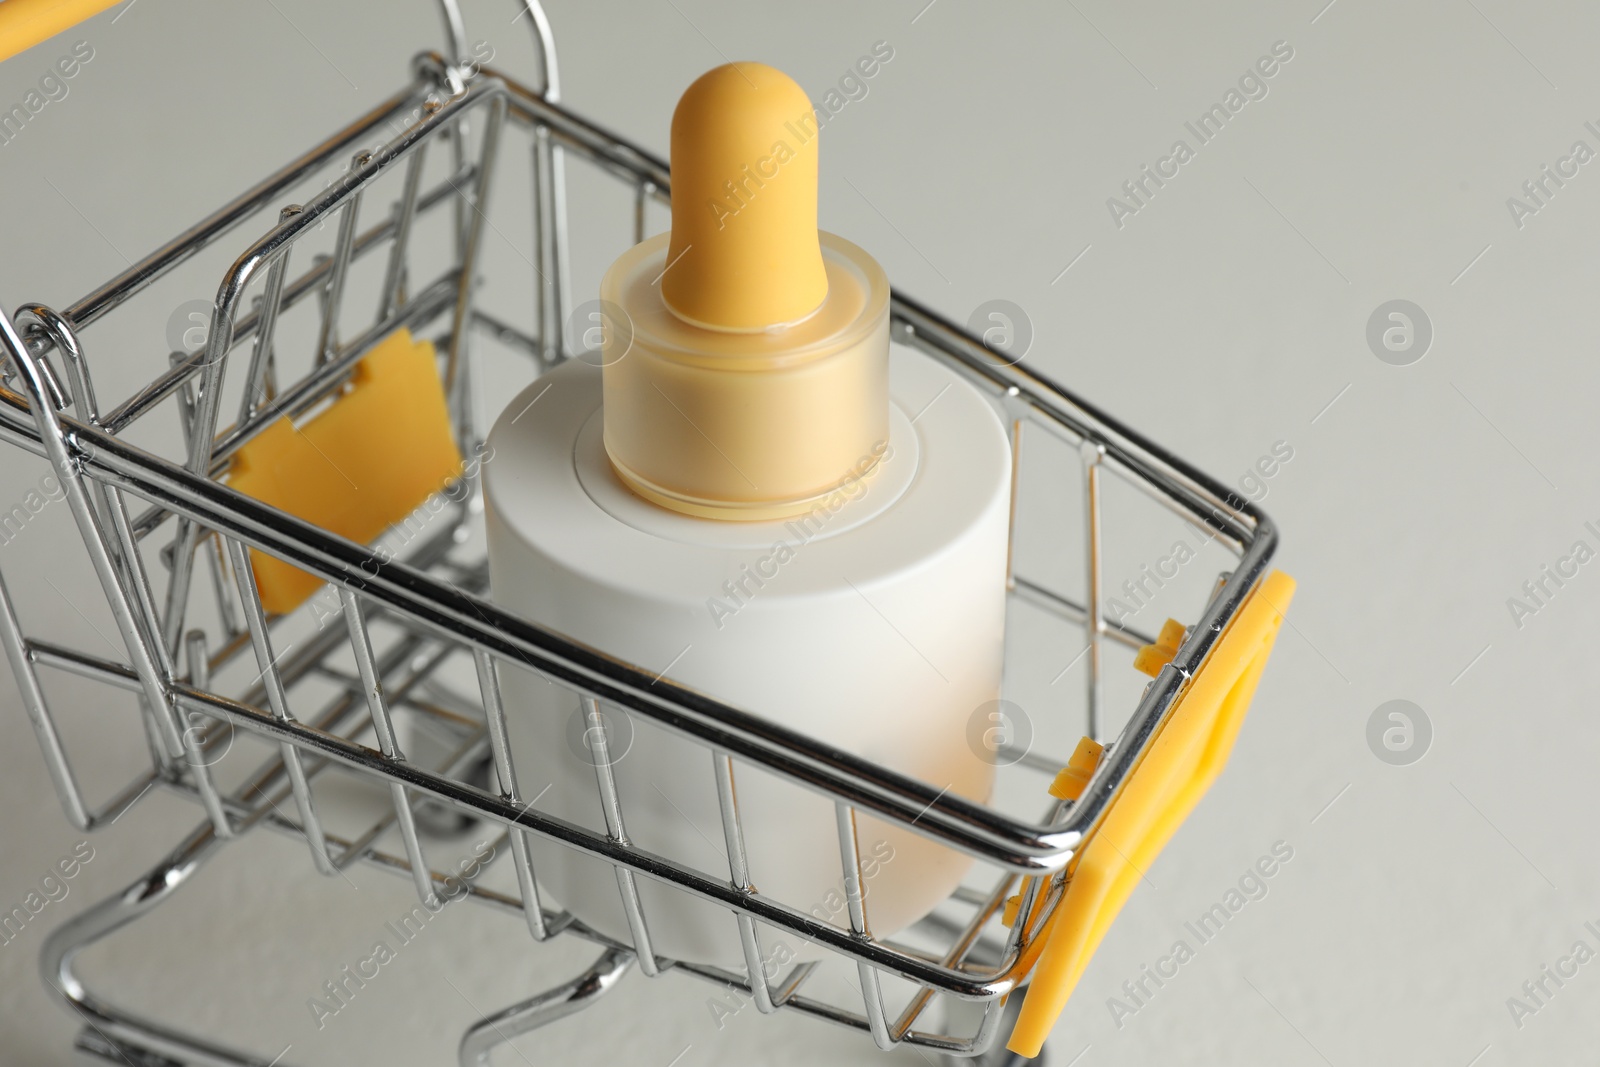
[{"xmin": 602, "ymin": 234, "xmax": 890, "ymax": 522}]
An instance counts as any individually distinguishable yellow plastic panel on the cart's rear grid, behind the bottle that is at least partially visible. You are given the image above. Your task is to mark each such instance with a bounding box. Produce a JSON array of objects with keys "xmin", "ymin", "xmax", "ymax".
[{"xmin": 227, "ymin": 330, "xmax": 461, "ymax": 613}]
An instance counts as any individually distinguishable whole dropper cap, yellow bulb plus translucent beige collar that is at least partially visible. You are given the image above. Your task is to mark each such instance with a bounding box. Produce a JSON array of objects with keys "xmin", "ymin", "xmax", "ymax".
[{"xmin": 600, "ymin": 62, "xmax": 890, "ymax": 520}]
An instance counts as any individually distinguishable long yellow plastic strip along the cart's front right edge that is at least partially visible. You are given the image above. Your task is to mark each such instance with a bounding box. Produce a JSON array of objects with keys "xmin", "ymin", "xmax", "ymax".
[{"xmin": 1006, "ymin": 571, "xmax": 1294, "ymax": 1057}]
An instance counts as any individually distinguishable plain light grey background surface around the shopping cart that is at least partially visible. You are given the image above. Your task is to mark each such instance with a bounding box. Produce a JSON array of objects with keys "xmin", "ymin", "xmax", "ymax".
[{"xmin": 0, "ymin": 0, "xmax": 1600, "ymax": 1067}]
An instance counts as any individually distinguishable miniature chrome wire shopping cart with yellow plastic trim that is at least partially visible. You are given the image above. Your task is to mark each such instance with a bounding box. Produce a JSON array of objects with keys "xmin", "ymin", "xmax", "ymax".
[{"xmin": 0, "ymin": 0, "xmax": 1291, "ymax": 1067}]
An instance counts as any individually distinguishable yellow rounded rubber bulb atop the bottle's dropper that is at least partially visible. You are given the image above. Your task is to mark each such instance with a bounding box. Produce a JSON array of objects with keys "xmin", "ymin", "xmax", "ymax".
[{"xmin": 661, "ymin": 62, "xmax": 827, "ymax": 333}]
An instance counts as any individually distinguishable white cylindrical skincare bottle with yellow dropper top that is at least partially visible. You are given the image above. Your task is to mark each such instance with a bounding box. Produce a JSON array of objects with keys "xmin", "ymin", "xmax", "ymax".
[{"xmin": 483, "ymin": 62, "xmax": 1011, "ymax": 968}]
